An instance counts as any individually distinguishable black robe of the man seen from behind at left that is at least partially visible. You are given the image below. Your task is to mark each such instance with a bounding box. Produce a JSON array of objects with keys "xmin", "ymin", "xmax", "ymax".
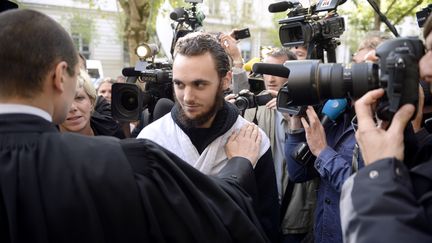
[{"xmin": 0, "ymin": 114, "xmax": 267, "ymax": 242}]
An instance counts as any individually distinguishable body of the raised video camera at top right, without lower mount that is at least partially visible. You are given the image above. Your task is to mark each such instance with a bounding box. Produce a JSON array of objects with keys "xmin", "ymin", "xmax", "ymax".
[{"xmin": 279, "ymin": 0, "xmax": 345, "ymax": 47}]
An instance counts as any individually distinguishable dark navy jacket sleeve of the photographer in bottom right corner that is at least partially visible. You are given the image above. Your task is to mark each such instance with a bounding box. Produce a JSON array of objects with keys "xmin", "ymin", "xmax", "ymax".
[{"xmin": 340, "ymin": 159, "xmax": 432, "ymax": 243}]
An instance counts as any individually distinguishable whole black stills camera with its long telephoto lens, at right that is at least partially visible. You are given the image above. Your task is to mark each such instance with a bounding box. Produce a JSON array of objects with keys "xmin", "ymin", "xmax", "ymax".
[{"xmin": 277, "ymin": 37, "xmax": 424, "ymax": 120}]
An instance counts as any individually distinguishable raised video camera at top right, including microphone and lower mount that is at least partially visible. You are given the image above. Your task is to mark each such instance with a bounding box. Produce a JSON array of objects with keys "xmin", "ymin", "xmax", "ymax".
[{"xmin": 268, "ymin": 0, "xmax": 345, "ymax": 62}]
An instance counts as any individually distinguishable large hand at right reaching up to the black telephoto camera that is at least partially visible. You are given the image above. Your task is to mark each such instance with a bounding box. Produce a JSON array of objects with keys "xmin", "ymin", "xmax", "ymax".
[{"xmin": 355, "ymin": 89, "xmax": 415, "ymax": 165}]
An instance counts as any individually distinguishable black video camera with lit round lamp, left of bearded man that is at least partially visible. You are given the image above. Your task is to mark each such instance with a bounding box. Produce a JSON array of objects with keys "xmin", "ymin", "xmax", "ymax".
[{"xmin": 111, "ymin": 43, "xmax": 173, "ymax": 121}]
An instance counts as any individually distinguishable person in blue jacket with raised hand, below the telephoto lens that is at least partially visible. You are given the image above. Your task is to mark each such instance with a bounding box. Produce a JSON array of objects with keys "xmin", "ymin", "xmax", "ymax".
[{"xmin": 285, "ymin": 101, "xmax": 356, "ymax": 243}]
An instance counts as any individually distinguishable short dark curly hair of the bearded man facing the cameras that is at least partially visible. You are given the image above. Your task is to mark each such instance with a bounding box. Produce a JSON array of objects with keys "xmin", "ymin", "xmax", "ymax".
[{"xmin": 174, "ymin": 32, "xmax": 231, "ymax": 79}]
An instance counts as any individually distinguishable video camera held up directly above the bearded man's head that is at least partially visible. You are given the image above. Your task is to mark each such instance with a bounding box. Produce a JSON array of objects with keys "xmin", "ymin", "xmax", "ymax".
[{"xmin": 170, "ymin": 0, "xmax": 205, "ymax": 55}]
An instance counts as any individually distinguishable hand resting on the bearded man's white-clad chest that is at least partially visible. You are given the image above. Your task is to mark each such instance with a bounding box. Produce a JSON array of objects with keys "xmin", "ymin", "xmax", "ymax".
[{"xmin": 225, "ymin": 123, "xmax": 261, "ymax": 166}]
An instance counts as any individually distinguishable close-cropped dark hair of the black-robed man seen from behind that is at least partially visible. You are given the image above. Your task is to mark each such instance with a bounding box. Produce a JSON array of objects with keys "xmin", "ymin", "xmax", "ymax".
[{"xmin": 0, "ymin": 10, "xmax": 78, "ymax": 98}]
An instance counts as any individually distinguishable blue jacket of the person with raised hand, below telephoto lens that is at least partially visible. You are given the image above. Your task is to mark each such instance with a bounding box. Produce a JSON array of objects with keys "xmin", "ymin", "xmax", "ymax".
[{"xmin": 285, "ymin": 112, "xmax": 363, "ymax": 243}]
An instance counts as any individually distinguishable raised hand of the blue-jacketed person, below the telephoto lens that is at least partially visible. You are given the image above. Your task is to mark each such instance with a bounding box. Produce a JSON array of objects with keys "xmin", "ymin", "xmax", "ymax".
[{"xmin": 301, "ymin": 106, "xmax": 327, "ymax": 157}]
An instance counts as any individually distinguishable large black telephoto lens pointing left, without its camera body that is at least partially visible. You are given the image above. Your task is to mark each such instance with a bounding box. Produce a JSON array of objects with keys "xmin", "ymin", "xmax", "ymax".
[{"xmin": 278, "ymin": 60, "xmax": 379, "ymax": 106}]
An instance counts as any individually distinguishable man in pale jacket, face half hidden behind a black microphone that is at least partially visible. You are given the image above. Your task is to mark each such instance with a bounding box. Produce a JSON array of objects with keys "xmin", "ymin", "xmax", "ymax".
[{"xmin": 244, "ymin": 48, "xmax": 316, "ymax": 242}]
